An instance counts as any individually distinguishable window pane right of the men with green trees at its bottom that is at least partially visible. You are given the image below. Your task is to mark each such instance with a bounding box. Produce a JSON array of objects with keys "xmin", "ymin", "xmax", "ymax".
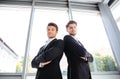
[{"xmin": 73, "ymin": 11, "xmax": 117, "ymax": 72}]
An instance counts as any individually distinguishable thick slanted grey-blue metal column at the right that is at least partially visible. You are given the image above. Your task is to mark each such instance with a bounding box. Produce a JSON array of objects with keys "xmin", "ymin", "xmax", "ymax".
[{"xmin": 98, "ymin": 1, "xmax": 120, "ymax": 70}]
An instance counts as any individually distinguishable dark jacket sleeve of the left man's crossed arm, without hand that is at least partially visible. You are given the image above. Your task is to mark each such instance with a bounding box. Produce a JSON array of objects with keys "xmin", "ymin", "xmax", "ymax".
[{"xmin": 36, "ymin": 40, "xmax": 64, "ymax": 63}]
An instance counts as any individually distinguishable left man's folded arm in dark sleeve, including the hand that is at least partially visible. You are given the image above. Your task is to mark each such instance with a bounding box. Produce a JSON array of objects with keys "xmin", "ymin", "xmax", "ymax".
[{"xmin": 32, "ymin": 40, "xmax": 64, "ymax": 68}]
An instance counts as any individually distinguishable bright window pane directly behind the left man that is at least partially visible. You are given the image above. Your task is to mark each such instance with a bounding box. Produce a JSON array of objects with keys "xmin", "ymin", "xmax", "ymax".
[{"xmin": 28, "ymin": 9, "xmax": 68, "ymax": 73}]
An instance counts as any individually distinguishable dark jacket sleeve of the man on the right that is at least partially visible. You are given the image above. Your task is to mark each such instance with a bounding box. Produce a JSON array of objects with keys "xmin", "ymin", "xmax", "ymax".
[{"xmin": 64, "ymin": 35, "xmax": 86, "ymax": 56}]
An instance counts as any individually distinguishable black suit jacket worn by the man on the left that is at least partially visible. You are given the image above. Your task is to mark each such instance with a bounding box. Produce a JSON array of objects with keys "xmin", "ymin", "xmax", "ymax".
[{"xmin": 31, "ymin": 39, "xmax": 64, "ymax": 79}]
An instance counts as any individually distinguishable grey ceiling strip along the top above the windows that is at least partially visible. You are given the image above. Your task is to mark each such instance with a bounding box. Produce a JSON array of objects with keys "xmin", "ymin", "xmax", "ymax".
[{"xmin": 0, "ymin": 0, "xmax": 120, "ymax": 11}]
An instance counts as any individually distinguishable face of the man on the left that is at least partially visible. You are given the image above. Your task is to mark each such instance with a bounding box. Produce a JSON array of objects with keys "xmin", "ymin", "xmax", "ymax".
[{"xmin": 47, "ymin": 26, "xmax": 57, "ymax": 38}]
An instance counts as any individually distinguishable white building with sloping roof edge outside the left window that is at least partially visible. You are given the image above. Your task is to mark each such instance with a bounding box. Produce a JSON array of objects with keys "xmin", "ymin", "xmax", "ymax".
[{"xmin": 0, "ymin": 38, "xmax": 18, "ymax": 72}]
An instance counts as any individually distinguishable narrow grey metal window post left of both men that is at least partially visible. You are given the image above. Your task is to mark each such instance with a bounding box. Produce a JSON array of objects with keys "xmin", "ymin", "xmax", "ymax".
[{"xmin": 22, "ymin": 0, "xmax": 35, "ymax": 79}]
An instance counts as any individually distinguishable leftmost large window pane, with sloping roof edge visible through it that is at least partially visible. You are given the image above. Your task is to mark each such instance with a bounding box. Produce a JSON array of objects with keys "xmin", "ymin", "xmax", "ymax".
[{"xmin": 0, "ymin": 6, "xmax": 30, "ymax": 73}]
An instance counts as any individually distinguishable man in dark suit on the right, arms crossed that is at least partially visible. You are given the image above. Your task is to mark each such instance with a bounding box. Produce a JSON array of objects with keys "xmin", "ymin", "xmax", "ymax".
[{"xmin": 64, "ymin": 20, "xmax": 91, "ymax": 79}]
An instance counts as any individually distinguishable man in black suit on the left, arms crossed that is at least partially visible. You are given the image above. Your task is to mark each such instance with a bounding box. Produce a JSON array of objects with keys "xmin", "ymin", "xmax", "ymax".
[{"xmin": 31, "ymin": 23, "xmax": 64, "ymax": 79}]
